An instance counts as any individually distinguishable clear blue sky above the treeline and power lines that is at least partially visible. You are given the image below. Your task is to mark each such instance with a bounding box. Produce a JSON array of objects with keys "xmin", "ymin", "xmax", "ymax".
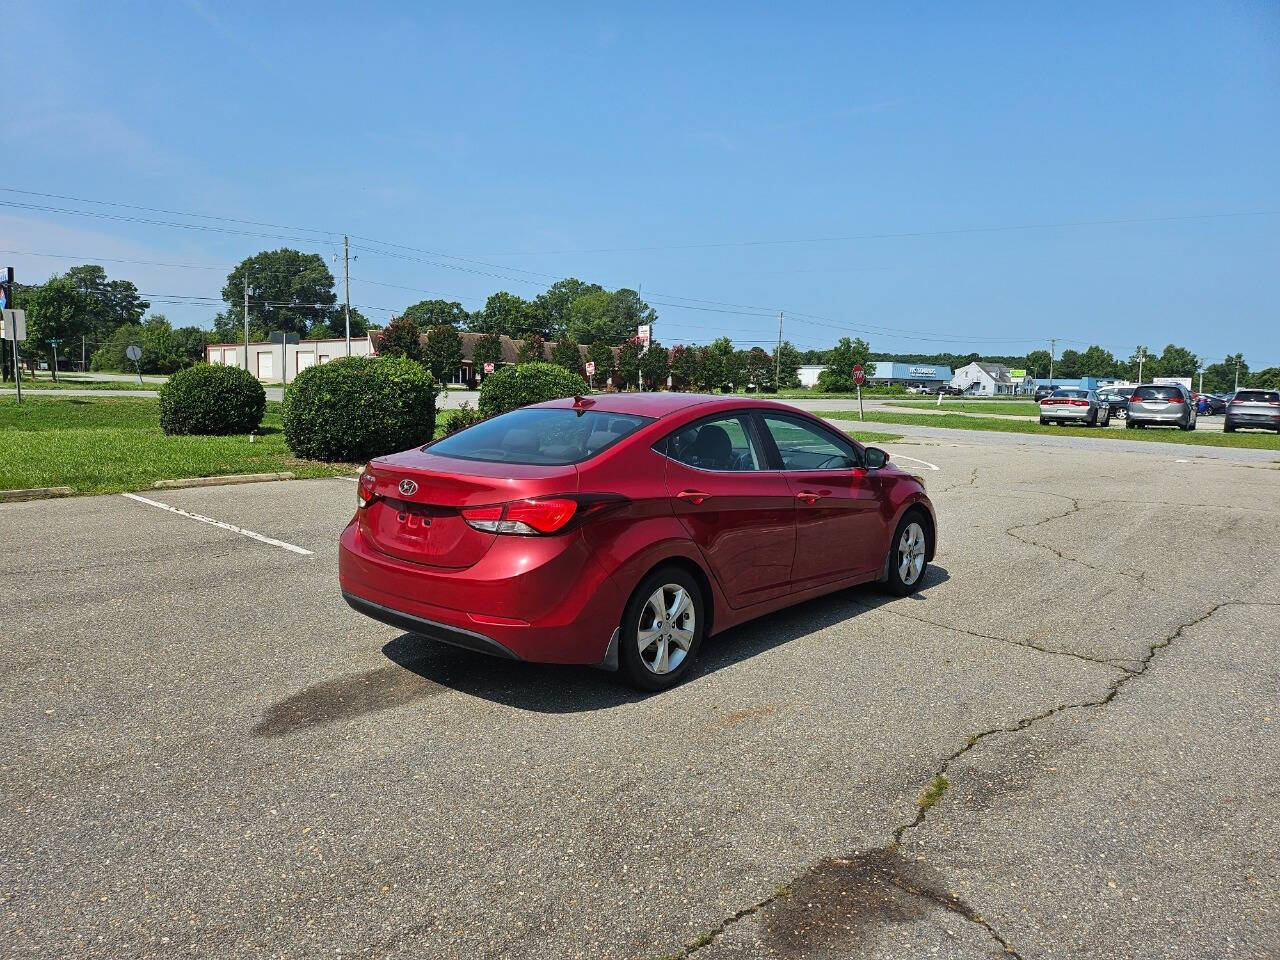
[{"xmin": 0, "ymin": 0, "xmax": 1280, "ymax": 367}]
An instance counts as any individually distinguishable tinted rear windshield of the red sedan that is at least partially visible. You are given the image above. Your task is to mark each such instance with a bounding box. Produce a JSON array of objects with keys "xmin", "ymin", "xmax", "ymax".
[{"xmin": 424, "ymin": 408, "xmax": 652, "ymax": 466}]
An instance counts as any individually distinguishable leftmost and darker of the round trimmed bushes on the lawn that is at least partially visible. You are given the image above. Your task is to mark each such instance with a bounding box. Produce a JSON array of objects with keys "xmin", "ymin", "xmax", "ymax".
[{"xmin": 160, "ymin": 364, "xmax": 266, "ymax": 435}]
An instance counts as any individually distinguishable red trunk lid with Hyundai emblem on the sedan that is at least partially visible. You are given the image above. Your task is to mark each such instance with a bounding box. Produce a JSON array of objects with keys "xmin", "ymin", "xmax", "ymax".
[{"xmin": 358, "ymin": 449, "xmax": 577, "ymax": 570}]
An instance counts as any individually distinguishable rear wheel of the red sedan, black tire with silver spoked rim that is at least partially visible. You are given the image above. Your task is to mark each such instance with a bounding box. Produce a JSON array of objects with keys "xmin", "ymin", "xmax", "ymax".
[{"xmin": 618, "ymin": 567, "xmax": 707, "ymax": 692}]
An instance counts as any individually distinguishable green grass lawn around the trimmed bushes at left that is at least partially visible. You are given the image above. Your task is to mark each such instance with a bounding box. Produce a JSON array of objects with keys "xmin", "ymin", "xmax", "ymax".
[{"xmin": 0, "ymin": 397, "xmax": 353, "ymax": 493}]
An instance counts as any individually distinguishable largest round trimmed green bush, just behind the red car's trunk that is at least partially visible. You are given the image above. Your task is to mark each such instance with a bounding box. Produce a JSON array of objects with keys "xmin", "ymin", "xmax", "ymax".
[{"xmin": 284, "ymin": 357, "xmax": 439, "ymax": 463}]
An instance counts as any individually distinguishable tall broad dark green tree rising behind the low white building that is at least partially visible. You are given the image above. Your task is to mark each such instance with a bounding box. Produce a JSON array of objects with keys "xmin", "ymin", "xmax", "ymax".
[{"xmin": 214, "ymin": 247, "xmax": 340, "ymax": 340}]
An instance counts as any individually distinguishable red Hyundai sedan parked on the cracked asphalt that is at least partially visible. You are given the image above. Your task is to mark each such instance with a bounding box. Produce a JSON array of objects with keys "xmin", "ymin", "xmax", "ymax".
[{"xmin": 338, "ymin": 393, "xmax": 937, "ymax": 690}]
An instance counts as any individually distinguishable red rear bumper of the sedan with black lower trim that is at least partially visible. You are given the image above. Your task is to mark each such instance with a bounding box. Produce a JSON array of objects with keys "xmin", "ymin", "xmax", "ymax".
[{"xmin": 338, "ymin": 522, "xmax": 626, "ymax": 664}]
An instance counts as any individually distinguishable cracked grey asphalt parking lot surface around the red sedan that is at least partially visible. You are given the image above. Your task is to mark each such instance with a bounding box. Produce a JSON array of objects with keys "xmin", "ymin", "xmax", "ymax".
[{"xmin": 0, "ymin": 435, "xmax": 1280, "ymax": 960}]
